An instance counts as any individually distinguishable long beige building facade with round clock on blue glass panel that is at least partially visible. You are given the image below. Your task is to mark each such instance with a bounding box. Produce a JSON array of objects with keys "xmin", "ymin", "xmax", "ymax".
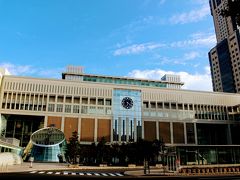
[{"xmin": 0, "ymin": 68, "xmax": 240, "ymax": 164}]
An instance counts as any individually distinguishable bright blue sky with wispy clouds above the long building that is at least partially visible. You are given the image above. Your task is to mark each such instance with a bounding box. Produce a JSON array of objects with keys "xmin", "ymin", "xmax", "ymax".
[{"xmin": 0, "ymin": 0, "xmax": 216, "ymax": 91}]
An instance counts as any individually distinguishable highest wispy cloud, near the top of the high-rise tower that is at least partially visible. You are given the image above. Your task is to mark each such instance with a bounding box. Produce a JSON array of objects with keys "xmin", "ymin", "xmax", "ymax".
[{"xmin": 169, "ymin": 2, "xmax": 210, "ymax": 24}]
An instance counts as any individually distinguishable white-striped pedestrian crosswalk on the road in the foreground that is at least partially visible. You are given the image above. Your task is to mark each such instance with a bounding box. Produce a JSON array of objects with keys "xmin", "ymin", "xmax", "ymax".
[{"xmin": 29, "ymin": 171, "xmax": 124, "ymax": 177}]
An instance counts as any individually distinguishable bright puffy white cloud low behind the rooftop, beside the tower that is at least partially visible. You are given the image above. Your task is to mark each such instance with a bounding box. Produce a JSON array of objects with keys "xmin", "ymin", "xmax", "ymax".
[{"xmin": 128, "ymin": 67, "xmax": 212, "ymax": 91}]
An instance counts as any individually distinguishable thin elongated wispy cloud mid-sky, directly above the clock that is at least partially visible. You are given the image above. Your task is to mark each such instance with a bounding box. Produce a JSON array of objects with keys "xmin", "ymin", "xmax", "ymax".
[{"xmin": 113, "ymin": 42, "xmax": 165, "ymax": 56}]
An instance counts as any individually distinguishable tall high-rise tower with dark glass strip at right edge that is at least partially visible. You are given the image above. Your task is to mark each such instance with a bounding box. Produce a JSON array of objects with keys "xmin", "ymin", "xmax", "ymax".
[{"xmin": 208, "ymin": 0, "xmax": 240, "ymax": 93}]
